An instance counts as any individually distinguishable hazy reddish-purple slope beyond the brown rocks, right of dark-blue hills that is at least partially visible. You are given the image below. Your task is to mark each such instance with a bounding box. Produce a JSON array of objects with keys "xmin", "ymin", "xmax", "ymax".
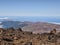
[{"xmin": 22, "ymin": 22, "xmax": 60, "ymax": 33}]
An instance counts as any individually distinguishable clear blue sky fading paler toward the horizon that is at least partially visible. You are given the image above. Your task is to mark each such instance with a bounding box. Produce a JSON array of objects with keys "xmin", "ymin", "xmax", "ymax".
[{"xmin": 0, "ymin": 0, "xmax": 60, "ymax": 16}]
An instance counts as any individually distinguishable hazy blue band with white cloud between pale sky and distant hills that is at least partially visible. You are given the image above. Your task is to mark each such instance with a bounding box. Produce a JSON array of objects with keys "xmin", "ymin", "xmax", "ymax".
[{"xmin": 0, "ymin": 16, "xmax": 60, "ymax": 23}]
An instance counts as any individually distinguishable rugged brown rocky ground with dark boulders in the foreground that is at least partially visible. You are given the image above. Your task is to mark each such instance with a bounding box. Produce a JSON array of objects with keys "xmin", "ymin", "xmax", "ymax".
[{"xmin": 0, "ymin": 28, "xmax": 60, "ymax": 45}]
